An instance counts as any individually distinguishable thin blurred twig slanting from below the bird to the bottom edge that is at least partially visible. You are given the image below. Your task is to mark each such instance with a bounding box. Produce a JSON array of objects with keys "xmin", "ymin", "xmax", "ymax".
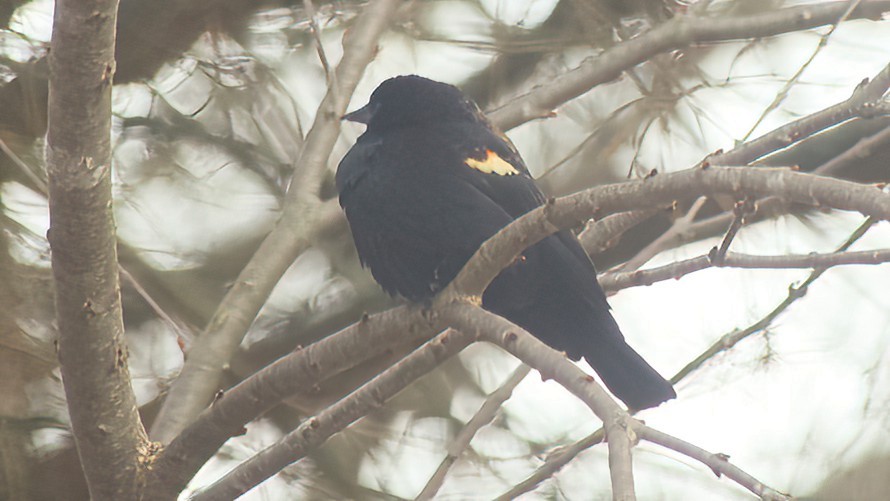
[{"xmin": 415, "ymin": 364, "xmax": 531, "ymax": 501}]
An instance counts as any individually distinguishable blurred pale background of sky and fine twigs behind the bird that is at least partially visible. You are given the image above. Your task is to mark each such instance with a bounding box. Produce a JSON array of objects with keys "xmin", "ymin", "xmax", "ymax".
[{"xmin": 0, "ymin": 0, "xmax": 890, "ymax": 500}]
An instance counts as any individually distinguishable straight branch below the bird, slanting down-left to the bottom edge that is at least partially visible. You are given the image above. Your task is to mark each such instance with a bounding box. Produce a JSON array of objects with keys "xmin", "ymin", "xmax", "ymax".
[{"xmin": 192, "ymin": 329, "xmax": 473, "ymax": 501}]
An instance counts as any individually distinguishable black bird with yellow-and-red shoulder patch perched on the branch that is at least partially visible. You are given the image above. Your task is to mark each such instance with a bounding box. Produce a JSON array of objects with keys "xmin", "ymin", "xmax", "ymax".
[{"xmin": 337, "ymin": 75, "xmax": 676, "ymax": 409}]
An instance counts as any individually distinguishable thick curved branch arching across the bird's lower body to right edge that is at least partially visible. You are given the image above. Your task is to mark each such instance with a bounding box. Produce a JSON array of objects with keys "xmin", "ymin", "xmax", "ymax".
[{"xmin": 441, "ymin": 167, "xmax": 890, "ymax": 297}]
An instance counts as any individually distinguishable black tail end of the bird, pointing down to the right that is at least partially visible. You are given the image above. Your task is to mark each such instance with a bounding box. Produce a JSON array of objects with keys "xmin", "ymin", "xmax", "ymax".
[{"xmin": 584, "ymin": 339, "xmax": 677, "ymax": 410}]
